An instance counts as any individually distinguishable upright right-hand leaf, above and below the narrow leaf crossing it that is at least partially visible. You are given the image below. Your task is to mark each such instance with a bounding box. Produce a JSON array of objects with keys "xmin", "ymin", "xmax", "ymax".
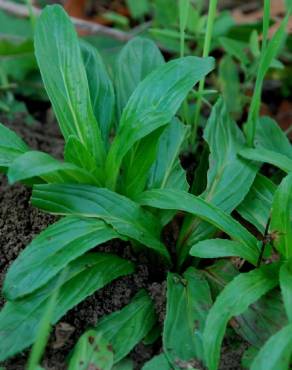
[{"xmin": 178, "ymin": 99, "xmax": 257, "ymax": 262}]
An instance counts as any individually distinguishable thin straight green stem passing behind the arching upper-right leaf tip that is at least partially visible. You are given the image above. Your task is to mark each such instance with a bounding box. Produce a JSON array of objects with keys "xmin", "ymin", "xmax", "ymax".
[{"xmin": 191, "ymin": 0, "xmax": 218, "ymax": 146}]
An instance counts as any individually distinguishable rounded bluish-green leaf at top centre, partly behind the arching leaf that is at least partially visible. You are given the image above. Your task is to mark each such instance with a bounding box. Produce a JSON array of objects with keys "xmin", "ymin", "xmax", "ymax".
[{"xmin": 115, "ymin": 37, "xmax": 164, "ymax": 118}]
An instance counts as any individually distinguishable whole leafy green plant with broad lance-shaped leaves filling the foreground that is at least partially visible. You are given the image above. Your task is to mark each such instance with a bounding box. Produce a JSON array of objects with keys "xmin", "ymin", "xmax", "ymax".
[{"xmin": 0, "ymin": 2, "xmax": 292, "ymax": 370}]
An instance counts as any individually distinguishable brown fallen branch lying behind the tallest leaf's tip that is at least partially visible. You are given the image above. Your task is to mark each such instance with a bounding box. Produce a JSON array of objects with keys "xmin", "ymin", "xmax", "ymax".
[{"xmin": 0, "ymin": 0, "xmax": 133, "ymax": 41}]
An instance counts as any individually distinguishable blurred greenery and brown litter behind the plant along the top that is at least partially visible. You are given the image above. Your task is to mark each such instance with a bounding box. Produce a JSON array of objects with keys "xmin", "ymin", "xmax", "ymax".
[{"xmin": 0, "ymin": 0, "xmax": 292, "ymax": 136}]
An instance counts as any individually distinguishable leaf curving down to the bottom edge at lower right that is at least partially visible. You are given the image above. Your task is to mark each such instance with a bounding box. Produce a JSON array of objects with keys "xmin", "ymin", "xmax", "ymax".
[{"xmin": 203, "ymin": 264, "xmax": 279, "ymax": 370}]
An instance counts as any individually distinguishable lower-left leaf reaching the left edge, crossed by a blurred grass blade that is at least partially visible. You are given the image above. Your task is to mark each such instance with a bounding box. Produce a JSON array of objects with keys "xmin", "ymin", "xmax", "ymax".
[{"xmin": 0, "ymin": 253, "xmax": 133, "ymax": 361}]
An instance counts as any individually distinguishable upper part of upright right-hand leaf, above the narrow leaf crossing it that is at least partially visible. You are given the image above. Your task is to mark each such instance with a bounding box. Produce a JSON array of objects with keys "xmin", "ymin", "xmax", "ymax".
[{"xmin": 203, "ymin": 99, "xmax": 257, "ymax": 212}]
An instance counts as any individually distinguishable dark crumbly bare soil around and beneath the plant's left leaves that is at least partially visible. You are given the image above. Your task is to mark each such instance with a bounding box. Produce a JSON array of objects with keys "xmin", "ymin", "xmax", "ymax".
[{"xmin": 0, "ymin": 116, "xmax": 246, "ymax": 370}]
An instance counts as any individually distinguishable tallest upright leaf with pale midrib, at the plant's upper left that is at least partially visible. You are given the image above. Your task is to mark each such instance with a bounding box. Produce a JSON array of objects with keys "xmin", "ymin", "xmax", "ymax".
[{"xmin": 35, "ymin": 5, "xmax": 105, "ymax": 167}]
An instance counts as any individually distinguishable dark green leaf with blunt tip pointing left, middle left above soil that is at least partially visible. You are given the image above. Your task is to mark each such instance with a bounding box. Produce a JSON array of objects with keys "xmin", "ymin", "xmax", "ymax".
[{"xmin": 32, "ymin": 184, "xmax": 169, "ymax": 258}]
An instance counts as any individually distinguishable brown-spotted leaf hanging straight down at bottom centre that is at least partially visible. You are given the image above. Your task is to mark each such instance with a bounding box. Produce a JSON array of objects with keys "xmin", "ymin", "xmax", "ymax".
[{"xmin": 163, "ymin": 267, "xmax": 212, "ymax": 366}]
